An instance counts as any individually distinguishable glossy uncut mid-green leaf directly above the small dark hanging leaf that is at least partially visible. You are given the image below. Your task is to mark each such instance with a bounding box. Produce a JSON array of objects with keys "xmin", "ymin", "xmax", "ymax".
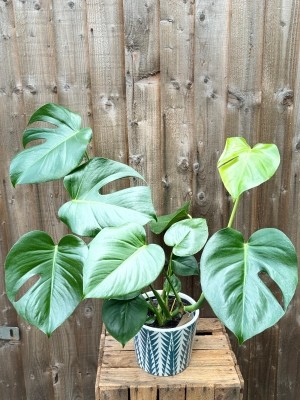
[{"xmin": 83, "ymin": 223, "xmax": 165, "ymax": 298}]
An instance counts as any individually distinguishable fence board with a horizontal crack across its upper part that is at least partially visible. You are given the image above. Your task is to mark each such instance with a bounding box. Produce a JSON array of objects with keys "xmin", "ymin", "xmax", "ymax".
[{"xmin": 124, "ymin": 0, "xmax": 163, "ymax": 214}]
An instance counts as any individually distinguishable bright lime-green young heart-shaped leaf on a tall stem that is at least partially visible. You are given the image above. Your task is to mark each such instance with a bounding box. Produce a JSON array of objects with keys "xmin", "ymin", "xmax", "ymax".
[{"xmin": 218, "ymin": 137, "xmax": 280, "ymax": 200}]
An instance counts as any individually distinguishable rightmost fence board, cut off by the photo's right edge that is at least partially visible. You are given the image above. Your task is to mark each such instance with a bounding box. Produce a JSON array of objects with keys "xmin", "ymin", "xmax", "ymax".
[{"xmin": 276, "ymin": 1, "xmax": 300, "ymax": 400}]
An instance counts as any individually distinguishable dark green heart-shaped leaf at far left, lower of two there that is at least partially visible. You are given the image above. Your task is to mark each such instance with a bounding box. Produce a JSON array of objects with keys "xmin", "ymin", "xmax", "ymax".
[{"xmin": 5, "ymin": 231, "xmax": 88, "ymax": 335}]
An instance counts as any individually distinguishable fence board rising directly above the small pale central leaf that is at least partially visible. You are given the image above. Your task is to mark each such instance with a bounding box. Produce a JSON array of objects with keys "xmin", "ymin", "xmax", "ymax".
[{"xmin": 160, "ymin": 0, "xmax": 197, "ymax": 212}]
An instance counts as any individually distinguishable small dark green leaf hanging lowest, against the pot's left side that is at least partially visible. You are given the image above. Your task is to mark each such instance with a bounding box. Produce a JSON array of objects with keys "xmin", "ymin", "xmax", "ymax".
[{"xmin": 102, "ymin": 296, "xmax": 148, "ymax": 347}]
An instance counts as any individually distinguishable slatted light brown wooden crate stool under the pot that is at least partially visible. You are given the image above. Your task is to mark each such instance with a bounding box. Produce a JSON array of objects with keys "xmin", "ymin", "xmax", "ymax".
[{"xmin": 96, "ymin": 318, "xmax": 244, "ymax": 400}]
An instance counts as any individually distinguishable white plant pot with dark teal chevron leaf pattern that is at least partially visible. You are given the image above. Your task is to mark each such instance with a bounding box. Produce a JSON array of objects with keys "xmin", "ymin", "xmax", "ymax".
[{"xmin": 134, "ymin": 294, "xmax": 199, "ymax": 376}]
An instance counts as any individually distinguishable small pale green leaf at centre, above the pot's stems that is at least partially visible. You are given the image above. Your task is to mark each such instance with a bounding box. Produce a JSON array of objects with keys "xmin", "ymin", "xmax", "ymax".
[{"xmin": 164, "ymin": 218, "xmax": 208, "ymax": 257}]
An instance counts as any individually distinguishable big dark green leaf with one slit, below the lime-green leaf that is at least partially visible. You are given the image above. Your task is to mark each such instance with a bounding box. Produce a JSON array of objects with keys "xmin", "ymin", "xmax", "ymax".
[{"xmin": 200, "ymin": 228, "xmax": 298, "ymax": 343}]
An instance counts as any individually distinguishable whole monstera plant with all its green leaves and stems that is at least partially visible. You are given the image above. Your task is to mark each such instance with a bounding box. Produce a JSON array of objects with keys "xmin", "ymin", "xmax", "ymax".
[{"xmin": 5, "ymin": 104, "xmax": 297, "ymax": 364}]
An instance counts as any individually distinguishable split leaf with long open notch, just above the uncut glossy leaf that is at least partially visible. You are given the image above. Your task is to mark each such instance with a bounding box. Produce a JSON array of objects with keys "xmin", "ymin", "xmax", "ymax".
[{"xmin": 58, "ymin": 157, "xmax": 155, "ymax": 236}]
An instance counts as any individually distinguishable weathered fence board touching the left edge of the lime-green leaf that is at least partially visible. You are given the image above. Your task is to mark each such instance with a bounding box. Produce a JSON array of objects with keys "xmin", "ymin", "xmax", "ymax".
[{"xmin": 194, "ymin": 0, "xmax": 230, "ymax": 234}]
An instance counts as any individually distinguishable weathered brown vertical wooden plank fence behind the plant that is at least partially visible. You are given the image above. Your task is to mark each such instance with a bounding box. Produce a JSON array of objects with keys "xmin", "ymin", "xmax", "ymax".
[{"xmin": 0, "ymin": 0, "xmax": 300, "ymax": 400}]
